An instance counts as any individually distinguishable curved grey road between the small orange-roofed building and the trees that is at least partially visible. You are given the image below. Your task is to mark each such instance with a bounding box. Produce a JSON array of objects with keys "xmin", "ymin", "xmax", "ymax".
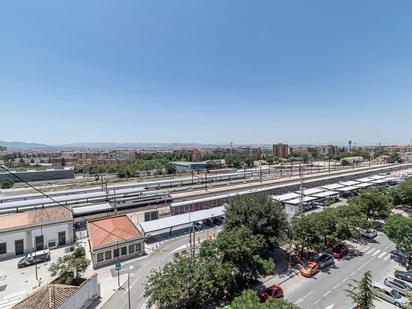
[{"xmin": 102, "ymin": 228, "xmax": 220, "ymax": 309}]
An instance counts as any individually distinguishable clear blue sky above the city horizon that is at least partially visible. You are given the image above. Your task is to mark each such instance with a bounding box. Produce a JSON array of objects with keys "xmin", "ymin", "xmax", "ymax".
[{"xmin": 0, "ymin": 0, "xmax": 412, "ymax": 144}]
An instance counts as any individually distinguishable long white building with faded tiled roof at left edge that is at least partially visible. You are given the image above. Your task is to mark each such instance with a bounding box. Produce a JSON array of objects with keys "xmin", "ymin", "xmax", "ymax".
[{"xmin": 0, "ymin": 206, "xmax": 74, "ymax": 259}]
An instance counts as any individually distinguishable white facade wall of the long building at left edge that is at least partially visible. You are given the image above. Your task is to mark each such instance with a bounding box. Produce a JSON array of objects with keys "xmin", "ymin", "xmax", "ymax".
[{"xmin": 0, "ymin": 222, "xmax": 74, "ymax": 260}]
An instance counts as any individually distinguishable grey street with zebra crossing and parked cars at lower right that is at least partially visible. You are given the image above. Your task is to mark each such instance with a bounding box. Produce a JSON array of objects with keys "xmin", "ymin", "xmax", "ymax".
[{"xmin": 282, "ymin": 233, "xmax": 403, "ymax": 309}]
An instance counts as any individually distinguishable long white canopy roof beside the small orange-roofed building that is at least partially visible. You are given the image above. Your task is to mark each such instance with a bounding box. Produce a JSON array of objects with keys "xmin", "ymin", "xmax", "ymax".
[{"xmin": 140, "ymin": 206, "xmax": 225, "ymax": 235}]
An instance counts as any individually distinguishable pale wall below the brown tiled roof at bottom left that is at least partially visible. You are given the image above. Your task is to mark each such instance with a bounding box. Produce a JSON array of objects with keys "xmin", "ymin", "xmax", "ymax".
[{"xmin": 58, "ymin": 274, "xmax": 100, "ymax": 309}]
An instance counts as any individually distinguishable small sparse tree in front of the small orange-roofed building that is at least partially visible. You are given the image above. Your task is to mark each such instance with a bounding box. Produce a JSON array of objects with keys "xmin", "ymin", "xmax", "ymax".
[{"xmin": 49, "ymin": 245, "xmax": 90, "ymax": 284}]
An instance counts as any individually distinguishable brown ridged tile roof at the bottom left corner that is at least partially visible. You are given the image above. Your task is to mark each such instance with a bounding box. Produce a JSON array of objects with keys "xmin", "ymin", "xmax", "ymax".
[{"xmin": 13, "ymin": 284, "xmax": 80, "ymax": 309}]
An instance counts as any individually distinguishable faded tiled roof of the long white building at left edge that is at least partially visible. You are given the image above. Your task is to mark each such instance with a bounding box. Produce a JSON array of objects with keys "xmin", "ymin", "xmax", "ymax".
[{"xmin": 0, "ymin": 206, "xmax": 73, "ymax": 231}]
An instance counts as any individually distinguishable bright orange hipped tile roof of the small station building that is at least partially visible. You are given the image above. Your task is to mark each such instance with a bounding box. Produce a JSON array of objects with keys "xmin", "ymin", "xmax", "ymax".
[{"xmin": 87, "ymin": 215, "xmax": 142, "ymax": 249}]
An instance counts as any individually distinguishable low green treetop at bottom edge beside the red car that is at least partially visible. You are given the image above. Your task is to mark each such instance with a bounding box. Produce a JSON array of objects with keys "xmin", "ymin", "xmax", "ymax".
[{"xmin": 230, "ymin": 289, "xmax": 299, "ymax": 309}]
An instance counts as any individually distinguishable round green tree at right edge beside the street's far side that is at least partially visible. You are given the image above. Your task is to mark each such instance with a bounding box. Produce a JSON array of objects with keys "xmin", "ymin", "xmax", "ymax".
[{"xmin": 384, "ymin": 214, "xmax": 412, "ymax": 251}]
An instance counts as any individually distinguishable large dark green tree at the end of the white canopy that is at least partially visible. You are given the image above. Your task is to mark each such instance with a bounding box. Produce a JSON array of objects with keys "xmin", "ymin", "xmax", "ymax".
[{"xmin": 224, "ymin": 193, "xmax": 288, "ymax": 245}]
